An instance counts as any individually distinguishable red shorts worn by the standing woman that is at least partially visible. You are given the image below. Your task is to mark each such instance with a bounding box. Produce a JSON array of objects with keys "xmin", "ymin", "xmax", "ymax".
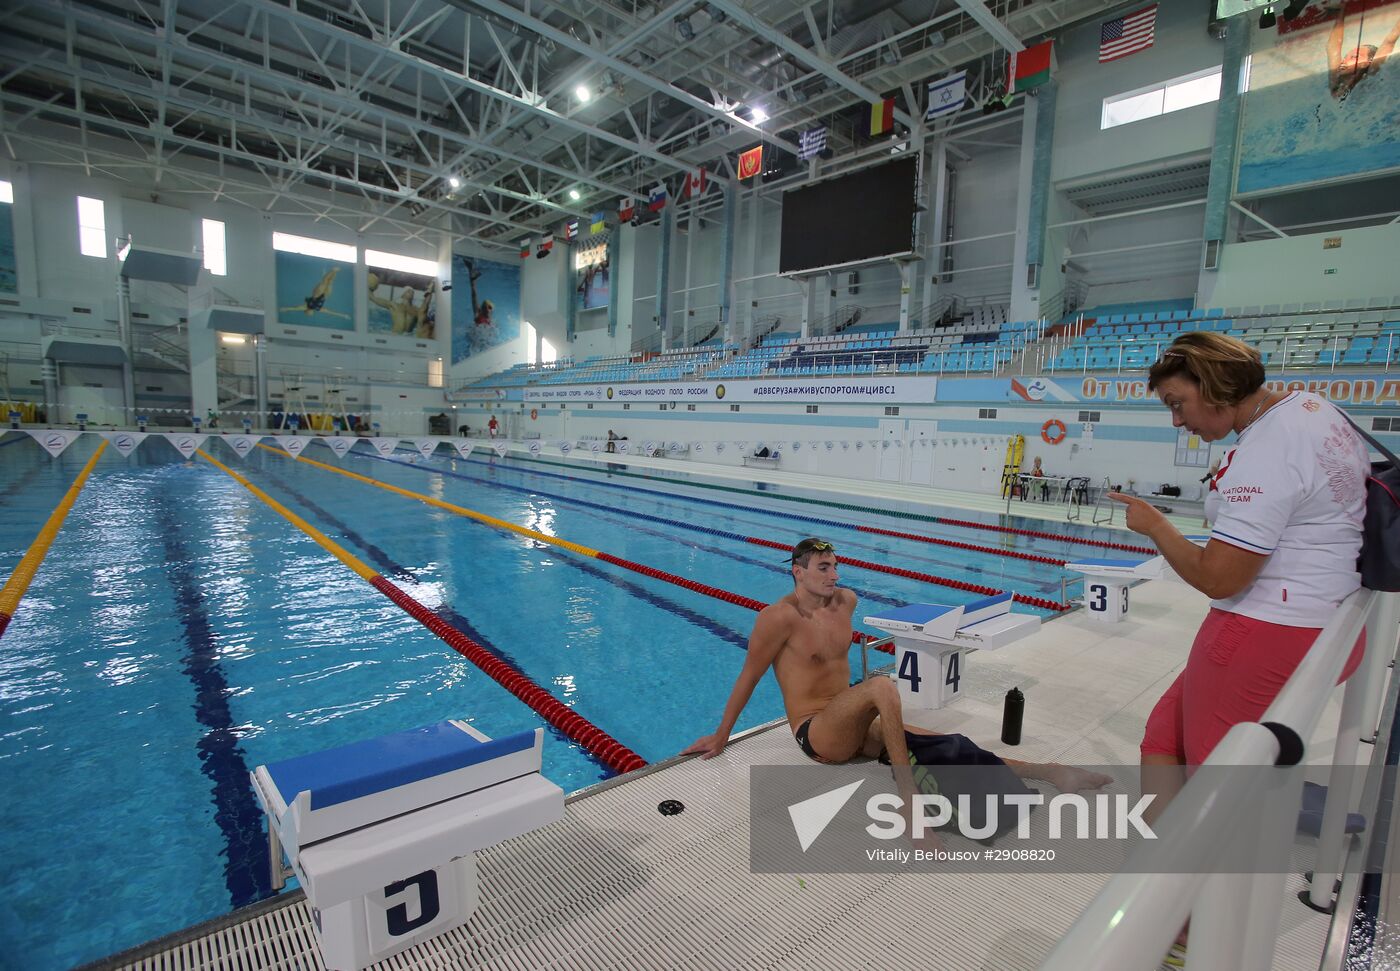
[{"xmin": 1142, "ymin": 607, "xmax": 1366, "ymax": 765}]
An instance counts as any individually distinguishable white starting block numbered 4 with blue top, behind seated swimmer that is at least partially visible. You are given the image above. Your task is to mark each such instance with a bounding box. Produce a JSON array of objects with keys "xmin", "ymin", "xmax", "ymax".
[{"xmin": 865, "ymin": 593, "xmax": 1040, "ymax": 708}]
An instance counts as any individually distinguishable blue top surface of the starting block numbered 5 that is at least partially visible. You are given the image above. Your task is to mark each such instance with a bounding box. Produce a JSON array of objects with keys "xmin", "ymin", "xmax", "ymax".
[{"xmin": 266, "ymin": 722, "xmax": 535, "ymax": 810}]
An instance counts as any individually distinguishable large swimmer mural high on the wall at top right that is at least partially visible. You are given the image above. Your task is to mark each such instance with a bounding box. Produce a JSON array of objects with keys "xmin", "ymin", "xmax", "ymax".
[{"xmin": 1226, "ymin": 0, "xmax": 1400, "ymax": 194}]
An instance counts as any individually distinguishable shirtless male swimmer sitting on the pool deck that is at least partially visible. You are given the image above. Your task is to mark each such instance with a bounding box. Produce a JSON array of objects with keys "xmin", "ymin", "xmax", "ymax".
[{"xmin": 682, "ymin": 539, "xmax": 1113, "ymax": 805}]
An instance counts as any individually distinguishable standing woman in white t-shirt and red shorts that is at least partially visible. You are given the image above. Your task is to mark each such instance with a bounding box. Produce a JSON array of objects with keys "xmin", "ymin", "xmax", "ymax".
[{"xmin": 1110, "ymin": 332, "xmax": 1371, "ymax": 816}]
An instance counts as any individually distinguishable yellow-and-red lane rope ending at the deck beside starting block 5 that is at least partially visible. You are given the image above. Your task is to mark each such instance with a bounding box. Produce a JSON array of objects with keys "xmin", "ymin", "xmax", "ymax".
[{"xmin": 200, "ymin": 449, "xmax": 647, "ymax": 772}]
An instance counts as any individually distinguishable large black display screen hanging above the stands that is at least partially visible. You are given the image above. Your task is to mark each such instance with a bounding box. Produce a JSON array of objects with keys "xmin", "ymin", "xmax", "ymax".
[{"xmin": 778, "ymin": 157, "xmax": 918, "ymax": 273}]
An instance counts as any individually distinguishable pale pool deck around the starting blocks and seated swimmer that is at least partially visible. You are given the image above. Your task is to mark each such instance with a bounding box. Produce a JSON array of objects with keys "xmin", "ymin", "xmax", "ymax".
[{"xmin": 84, "ymin": 459, "xmax": 1340, "ymax": 971}]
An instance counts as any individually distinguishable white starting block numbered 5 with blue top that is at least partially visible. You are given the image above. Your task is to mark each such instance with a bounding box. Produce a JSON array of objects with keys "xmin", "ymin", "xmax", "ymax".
[{"xmin": 252, "ymin": 721, "xmax": 564, "ymax": 971}]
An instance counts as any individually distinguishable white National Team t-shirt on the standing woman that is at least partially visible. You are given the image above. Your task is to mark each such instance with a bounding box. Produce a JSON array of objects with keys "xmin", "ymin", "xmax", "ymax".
[{"xmin": 1205, "ymin": 392, "xmax": 1371, "ymax": 627}]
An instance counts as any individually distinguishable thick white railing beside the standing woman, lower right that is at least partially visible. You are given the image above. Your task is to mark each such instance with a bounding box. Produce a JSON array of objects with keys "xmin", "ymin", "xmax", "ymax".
[{"xmin": 1040, "ymin": 589, "xmax": 1400, "ymax": 971}]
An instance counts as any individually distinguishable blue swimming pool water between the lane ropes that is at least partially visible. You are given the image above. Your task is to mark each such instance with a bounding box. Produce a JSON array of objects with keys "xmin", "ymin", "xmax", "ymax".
[{"xmin": 0, "ymin": 435, "xmax": 1112, "ymax": 971}]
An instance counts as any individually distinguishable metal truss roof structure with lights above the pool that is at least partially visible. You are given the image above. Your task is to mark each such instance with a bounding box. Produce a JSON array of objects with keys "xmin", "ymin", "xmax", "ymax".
[{"xmin": 0, "ymin": 0, "xmax": 1116, "ymax": 254}]
